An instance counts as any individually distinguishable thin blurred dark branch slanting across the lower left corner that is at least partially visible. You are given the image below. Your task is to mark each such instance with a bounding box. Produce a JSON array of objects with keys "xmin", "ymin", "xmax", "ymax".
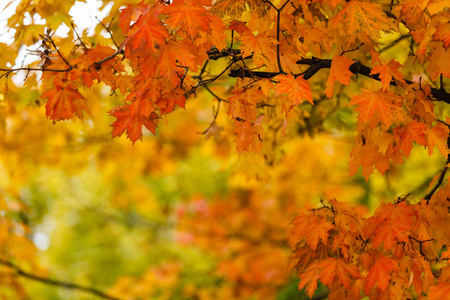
[{"xmin": 0, "ymin": 259, "xmax": 120, "ymax": 300}]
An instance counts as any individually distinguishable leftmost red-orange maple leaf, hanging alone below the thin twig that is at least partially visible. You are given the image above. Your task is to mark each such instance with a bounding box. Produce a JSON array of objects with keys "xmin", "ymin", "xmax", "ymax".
[{"xmin": 40, "ymin": 85, "xmax": 90, "ymax": 121}]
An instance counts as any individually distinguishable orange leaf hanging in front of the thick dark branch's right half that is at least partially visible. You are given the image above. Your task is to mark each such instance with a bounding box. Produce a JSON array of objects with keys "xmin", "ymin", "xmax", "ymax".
[{"xmin": 325, "ymin": 54, "xmax": 354, "ymax": 98}]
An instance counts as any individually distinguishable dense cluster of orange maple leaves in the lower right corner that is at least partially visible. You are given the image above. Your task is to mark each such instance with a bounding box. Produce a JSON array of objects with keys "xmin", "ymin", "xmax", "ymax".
[{"xmin": 290, "ymin": 185, "xmax": 449, "ymax": 299}]
